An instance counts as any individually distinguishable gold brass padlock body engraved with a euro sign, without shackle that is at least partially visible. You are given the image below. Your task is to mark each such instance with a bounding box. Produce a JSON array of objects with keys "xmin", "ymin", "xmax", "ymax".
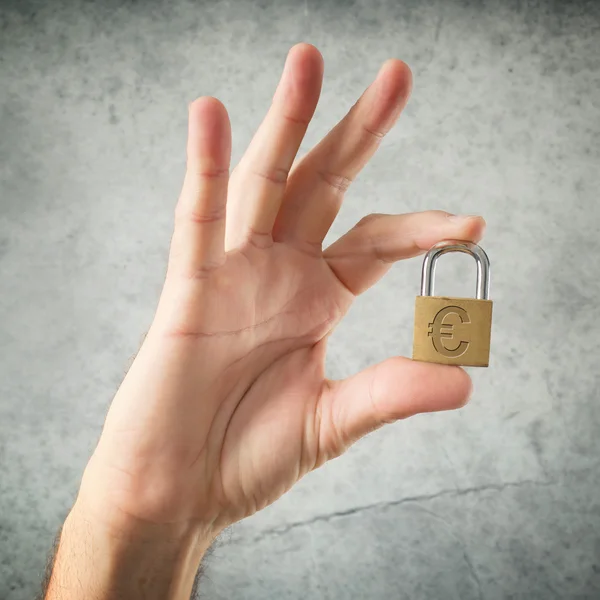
[{"xmin": 413, "ymin": 296, "xmax": 493, "ymax": 367}]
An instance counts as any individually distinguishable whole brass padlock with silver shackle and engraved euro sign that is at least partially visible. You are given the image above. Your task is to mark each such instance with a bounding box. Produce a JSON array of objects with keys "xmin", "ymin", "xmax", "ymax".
[{"xmin": 413, "ymin": 240, "xmax": 492, "ymax": 367}]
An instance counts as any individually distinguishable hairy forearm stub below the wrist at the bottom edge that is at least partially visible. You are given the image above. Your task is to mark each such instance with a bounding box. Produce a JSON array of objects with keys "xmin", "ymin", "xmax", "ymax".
[{"xmin": 45, "ymin": 503, "xmax": 210, "ymax": 600}]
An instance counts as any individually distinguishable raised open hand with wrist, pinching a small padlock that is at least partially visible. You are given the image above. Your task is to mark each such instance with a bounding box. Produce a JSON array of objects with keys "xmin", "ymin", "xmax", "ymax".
[{"xmin": 46, "ymin": 44, "xmax": 485, "ymax": 600}]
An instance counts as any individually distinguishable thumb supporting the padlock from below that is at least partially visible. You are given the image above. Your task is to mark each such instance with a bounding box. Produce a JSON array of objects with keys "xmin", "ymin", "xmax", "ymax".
[{"xmin": 316, "ymin": 357, "xmax": 472, "ymax": 465}]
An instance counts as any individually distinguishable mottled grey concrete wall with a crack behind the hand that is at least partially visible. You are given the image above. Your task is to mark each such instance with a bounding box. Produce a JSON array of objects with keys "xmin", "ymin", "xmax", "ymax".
[{"xmin": 0, "ymin": 0, "xmax": 600, "ymax": 600}]
